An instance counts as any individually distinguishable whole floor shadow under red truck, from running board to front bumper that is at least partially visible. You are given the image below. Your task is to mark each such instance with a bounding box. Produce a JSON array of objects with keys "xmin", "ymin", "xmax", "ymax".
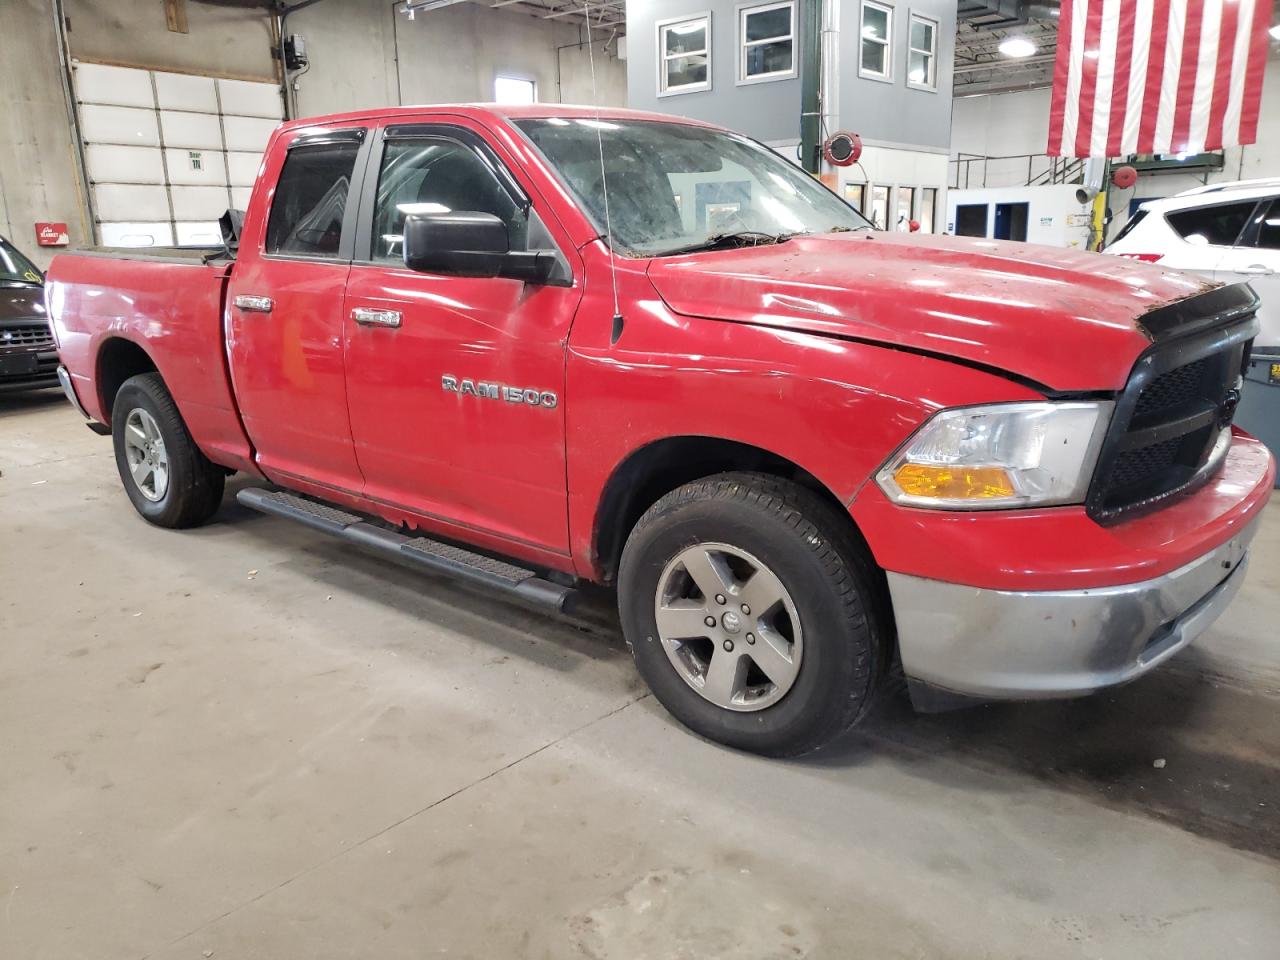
[{"xmin": 220, "ymin": 483, "xmax": 1280, "ymax": 859}]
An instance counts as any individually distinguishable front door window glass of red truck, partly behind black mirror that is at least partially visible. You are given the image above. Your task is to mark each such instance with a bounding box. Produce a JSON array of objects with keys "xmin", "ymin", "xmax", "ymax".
[{"xmin": 372, "ymin": 137, "xmax": 529, "ymax": 262}]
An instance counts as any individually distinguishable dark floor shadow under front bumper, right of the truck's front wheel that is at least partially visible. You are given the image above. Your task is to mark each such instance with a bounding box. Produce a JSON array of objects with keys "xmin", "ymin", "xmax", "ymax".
[{"xmin": 819, "ymin": 648, "xmax": 1280, "ymax": 859}]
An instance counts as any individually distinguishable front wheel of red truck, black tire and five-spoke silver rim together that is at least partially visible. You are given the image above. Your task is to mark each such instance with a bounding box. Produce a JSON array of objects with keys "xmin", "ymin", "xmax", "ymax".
[{"xmin": 618, "ymin": 474, "xmax": 886, "ymax": 756}]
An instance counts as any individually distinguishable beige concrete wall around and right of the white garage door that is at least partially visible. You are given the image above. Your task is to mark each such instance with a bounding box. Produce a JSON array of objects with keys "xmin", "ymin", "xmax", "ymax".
[{"xmin": 0, "ymin": 0, "xmax": 626, "ymax": 268}]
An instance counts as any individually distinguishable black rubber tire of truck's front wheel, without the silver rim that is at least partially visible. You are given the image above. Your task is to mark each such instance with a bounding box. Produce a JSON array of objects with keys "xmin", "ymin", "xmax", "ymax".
[{"xmin": 618, "ymin": 472, "xmax": 888, "ymax": 756}]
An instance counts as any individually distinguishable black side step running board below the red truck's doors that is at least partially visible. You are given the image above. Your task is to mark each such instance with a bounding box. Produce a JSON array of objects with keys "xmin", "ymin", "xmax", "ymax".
[{"xmin": 236, "ymin": 486, "xmax": 577, "ymax": 613}]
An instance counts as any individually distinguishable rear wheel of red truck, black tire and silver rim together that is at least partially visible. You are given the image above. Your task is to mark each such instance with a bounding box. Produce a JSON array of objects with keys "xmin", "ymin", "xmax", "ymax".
[{"xmin": 111, "ymin": 374, "xmax": 227, "ymax": 527}]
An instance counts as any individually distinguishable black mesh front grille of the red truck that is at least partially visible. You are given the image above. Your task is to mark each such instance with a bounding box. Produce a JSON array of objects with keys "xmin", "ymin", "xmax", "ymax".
[{"xmin": 1087, "ymin": 291, "xmax": 1257, "ymax": 522}]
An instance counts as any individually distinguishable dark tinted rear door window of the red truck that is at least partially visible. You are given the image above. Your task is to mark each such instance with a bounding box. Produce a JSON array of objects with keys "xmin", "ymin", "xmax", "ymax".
[{"xmin": 266, "ymin": 140, "xmax": 360, "ymax": 257}]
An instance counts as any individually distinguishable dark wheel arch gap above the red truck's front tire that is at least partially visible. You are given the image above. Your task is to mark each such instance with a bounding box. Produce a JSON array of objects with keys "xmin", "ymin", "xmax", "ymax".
[{"xmin": 591, "ymin": 435, "xmax": 870, "ymax": 582}]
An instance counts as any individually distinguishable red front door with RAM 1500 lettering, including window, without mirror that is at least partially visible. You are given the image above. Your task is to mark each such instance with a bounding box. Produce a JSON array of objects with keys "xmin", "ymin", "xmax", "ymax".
[{"xmin": 344, "ymin": 124, "xmax": 581, "ymax": 556}]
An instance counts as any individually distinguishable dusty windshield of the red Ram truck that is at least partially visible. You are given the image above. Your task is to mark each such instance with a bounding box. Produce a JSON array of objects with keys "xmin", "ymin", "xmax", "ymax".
[{"xmin": 515, "ymin": 116, "xmax": 872, "ymax": 256}]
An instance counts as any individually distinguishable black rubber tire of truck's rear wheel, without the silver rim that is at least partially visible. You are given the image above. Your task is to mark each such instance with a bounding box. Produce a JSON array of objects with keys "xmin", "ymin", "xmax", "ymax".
[{"xmin": 111, "ymin": 374, "xmax": 227, "ymax": 529}]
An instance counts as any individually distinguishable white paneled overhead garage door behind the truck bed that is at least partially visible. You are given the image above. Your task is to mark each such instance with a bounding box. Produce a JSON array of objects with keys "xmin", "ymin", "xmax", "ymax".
[{"xmin": 74, "ymin": 61, "xmax": 280, "ymax": 247}]
